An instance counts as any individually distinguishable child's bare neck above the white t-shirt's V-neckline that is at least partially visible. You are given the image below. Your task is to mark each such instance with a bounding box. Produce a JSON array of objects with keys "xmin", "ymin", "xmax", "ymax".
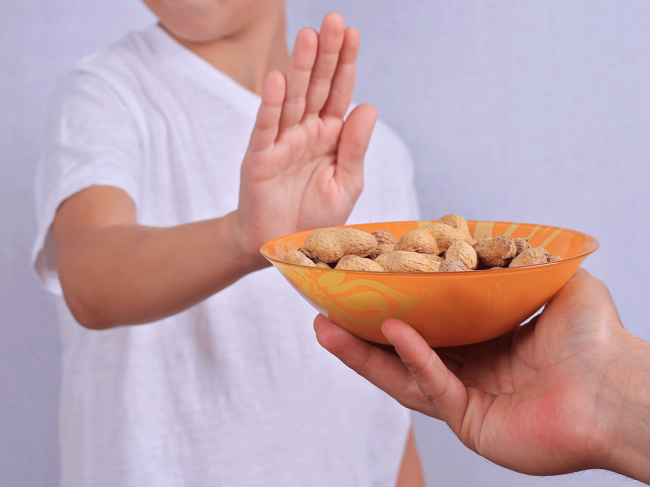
[{"xmin": 178, "ymin": 5, "xmax": 289, "ymax": 95}]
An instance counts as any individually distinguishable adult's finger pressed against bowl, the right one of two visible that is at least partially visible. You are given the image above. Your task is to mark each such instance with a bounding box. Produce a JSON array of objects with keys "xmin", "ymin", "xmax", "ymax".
[{"xmin": 381, "ymin": 320, "xmax": 468, "ymax": 436}]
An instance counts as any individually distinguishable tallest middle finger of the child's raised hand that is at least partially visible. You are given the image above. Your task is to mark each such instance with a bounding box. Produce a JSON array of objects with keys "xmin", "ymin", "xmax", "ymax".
[{"xmin": 305, "ymin": 13, "xmax": 345, "ymax": 114}]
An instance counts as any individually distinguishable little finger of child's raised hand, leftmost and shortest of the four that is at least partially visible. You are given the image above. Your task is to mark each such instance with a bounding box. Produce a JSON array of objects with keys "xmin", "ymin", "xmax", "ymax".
[{"xmin": 248, "ymin": 71, "xmax": 286, "ymax": 152}]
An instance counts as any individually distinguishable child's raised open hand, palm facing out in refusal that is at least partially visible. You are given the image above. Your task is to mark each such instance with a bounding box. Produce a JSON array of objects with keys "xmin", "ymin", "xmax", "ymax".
[{"xmin": 233, "ymin": 14, "xmax": 377, "ymax": 255}]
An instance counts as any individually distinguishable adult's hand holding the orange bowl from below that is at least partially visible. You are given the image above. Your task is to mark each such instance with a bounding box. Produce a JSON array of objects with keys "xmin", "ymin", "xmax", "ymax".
[{"xmin": 314, "ymin": 270, "xmax": 650, "ymax": 483}]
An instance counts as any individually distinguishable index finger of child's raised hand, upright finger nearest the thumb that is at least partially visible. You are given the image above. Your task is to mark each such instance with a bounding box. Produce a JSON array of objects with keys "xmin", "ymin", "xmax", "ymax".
[{"xmin": 320, "ymin": 27, "xmax": 359, "ymax": 118}]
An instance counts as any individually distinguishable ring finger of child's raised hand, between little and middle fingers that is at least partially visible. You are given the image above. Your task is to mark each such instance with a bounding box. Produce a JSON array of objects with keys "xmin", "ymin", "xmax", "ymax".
[{"xmin": 280, "ymin": 27, "xmax": 318, "ymax": 128}]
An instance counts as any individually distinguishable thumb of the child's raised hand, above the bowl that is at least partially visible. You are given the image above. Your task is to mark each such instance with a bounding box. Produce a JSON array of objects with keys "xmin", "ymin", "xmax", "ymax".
[{"xmin": 335, "ymin": 105, "xmax": 377, "ymax": 193}]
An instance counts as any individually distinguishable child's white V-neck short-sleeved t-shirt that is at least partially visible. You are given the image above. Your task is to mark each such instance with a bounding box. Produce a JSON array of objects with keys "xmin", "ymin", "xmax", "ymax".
[{"xmin": 34, "ymin": 26, "xmax": 418, "ymax": 487}]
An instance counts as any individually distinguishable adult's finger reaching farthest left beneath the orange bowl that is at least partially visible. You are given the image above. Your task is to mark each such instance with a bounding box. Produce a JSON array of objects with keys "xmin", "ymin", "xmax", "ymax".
[{"xmin": 314, "ymin": 315, "xmax": 437, "ymax": 417}]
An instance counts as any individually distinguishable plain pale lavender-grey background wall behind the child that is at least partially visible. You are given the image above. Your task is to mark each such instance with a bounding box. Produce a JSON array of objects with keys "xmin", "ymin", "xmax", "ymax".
[{"xmin": 0, "ymin": 0, "xmax": 650, "ymax": 487}]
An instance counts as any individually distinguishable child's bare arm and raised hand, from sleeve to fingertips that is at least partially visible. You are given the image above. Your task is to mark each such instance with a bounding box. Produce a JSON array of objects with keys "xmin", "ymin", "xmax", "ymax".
[{"xmin": 52, "ymin": 14, "xmax": 377, "ymax": 329}]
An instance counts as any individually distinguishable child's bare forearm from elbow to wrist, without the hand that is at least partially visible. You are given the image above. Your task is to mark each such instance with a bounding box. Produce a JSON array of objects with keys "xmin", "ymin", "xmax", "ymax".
[{"xmin": 59, "ymin": 214, "xmax": 267, "ymax": 329}]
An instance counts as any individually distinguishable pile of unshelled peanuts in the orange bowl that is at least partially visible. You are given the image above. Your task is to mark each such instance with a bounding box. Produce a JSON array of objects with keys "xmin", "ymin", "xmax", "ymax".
[{"xmin": 284, "ymin": 215, "xmax": 560, "ymax": 272}]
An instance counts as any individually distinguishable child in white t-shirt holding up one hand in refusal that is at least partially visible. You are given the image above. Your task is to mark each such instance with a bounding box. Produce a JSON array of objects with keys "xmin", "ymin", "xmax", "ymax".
[{"xmin": 34, "ymin": 0, "xmax": 422, "ymax": 487}]
